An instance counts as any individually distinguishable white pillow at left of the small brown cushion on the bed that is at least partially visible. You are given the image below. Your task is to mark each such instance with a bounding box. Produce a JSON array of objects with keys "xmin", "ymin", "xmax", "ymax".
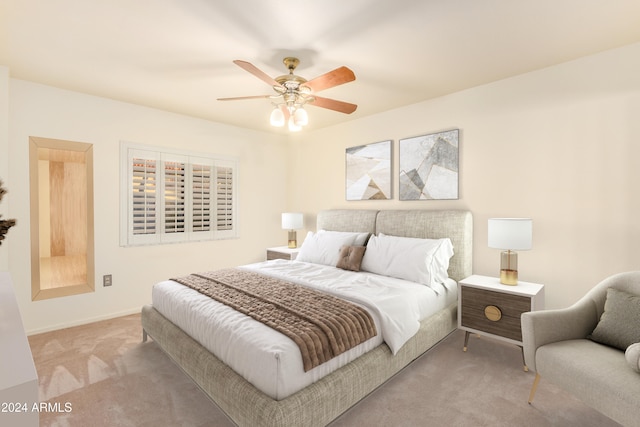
[{"xmin": 296, "ymin": 230, "xmax": 369, "ymax": 267}]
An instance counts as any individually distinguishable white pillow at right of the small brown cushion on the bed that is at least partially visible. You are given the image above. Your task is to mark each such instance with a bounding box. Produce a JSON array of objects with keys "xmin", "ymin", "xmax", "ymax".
[{"xmin": 360, "ymin": 233, "xmax": 453, "ymax": 286}]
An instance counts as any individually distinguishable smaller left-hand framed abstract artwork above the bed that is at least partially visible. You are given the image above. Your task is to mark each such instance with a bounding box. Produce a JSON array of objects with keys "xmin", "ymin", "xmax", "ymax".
[{"xmin": 346, "ymin": 140, "xmax": 392, "ymax": 200}]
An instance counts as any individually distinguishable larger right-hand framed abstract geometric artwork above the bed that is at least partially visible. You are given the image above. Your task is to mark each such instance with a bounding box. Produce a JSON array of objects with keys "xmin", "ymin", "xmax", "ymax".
[{"xmin": 399, "ymin": 129, "xmax": 459, "ymax": 200}]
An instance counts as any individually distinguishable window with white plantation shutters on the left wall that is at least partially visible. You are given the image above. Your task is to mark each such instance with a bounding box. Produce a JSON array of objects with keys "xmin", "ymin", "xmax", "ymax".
[{"xmin": 120, "ymin": 143, "xmax": 238, "ymax": 246}]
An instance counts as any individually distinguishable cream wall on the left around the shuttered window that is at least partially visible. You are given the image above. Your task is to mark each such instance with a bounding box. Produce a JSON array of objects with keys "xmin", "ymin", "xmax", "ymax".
[{"xmin": 6, "ymin": 80, "xmax": 287, "ymax": 333}]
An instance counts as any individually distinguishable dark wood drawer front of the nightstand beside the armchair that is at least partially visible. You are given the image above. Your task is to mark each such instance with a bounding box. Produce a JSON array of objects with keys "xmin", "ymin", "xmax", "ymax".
[{"xmin": 460, "ymin": 286, "xmax": 531, "ymax": 341}]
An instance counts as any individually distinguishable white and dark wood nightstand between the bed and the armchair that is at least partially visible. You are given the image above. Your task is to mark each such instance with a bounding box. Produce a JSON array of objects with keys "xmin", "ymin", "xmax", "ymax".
[{"xmin": 458, "ymin": 275, "xmax": 544, "ymax": 371}]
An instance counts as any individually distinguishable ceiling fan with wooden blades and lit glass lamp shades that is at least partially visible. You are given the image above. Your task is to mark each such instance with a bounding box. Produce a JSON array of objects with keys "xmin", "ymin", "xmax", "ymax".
[{"xmin": 218, "ymin": 57, "xmax": 358, "ymax": 131}]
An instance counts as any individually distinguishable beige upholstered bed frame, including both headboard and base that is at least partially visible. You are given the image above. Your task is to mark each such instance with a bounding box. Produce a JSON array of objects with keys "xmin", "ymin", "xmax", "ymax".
[{"xmin": 142, "ymin": 210, "xmax": 473, "ymax": 426}]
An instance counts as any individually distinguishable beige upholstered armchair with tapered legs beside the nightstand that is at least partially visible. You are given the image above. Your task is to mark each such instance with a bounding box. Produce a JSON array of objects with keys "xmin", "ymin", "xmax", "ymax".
[{"xmin": 522, "ymin": 271, "xmax": 640, "ymax": 425}]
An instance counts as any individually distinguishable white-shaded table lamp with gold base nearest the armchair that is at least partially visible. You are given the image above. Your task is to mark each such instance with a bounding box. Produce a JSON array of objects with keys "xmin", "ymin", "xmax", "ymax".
[{"xmin": 488, "ymin": 218, "xmax": 533, "ymax": 286}]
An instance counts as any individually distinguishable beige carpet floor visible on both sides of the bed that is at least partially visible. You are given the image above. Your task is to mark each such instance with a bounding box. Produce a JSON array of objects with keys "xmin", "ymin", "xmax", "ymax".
[{"xmin": 29, "ymin": 315, "xmax": 618, "ymax": 427}]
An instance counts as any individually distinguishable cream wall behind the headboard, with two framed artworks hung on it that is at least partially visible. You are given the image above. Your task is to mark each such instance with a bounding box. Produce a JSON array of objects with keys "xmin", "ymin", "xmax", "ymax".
[{"xmin": 289, "ymin": 44, "xmax": 640, "ymax": 308}]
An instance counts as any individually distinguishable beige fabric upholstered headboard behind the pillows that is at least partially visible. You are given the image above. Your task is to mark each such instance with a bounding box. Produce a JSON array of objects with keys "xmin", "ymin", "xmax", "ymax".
[{"xmin": 316, "ymin": 209, "xmax": 473, "ymax": 281}]
